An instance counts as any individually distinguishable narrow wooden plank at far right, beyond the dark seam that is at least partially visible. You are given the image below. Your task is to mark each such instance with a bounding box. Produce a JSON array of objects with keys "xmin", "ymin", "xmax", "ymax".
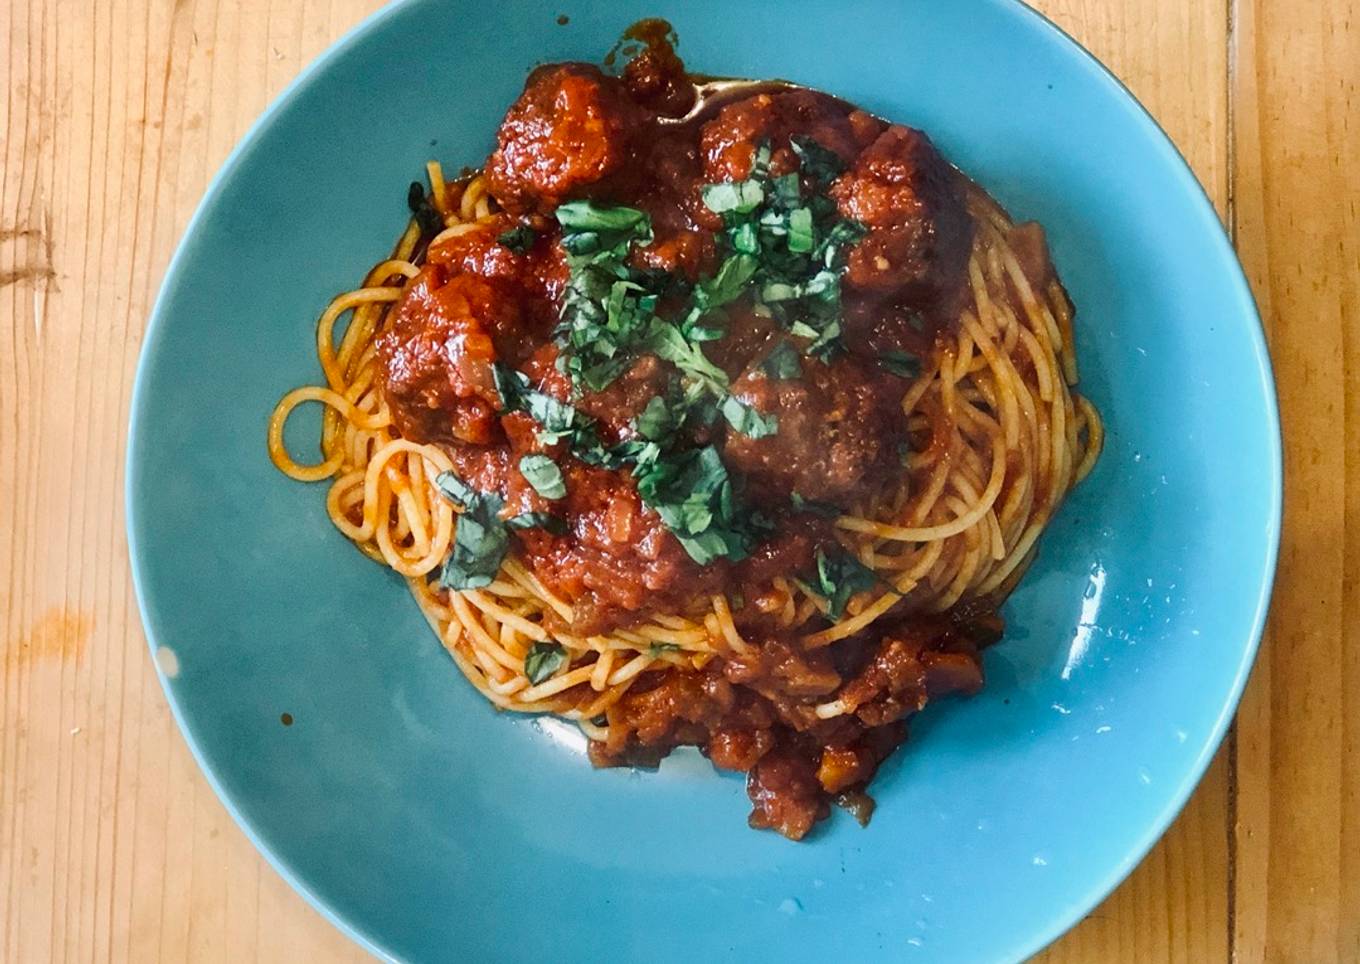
[{"xmin": 1232, "ymin": 0, "xmax": 1360, "ymax": 961}]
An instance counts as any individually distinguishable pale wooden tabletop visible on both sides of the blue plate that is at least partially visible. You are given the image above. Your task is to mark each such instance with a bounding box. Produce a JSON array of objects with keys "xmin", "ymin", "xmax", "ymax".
[{"xmin": 0, "ymin": 0, "xmax": 1360, "ymax": 964}]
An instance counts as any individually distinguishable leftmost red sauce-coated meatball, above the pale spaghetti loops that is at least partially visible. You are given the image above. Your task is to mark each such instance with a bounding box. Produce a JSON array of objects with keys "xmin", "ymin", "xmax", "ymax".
[{"xmin": 377, "ymin": 265, "xmax": 521, "ymax": 445}]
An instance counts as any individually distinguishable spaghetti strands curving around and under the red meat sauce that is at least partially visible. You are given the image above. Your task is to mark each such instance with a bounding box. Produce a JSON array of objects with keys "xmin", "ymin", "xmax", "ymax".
[{"xmin": 268, "ymin": 48, "xmax": 1102, "ymax": 836}]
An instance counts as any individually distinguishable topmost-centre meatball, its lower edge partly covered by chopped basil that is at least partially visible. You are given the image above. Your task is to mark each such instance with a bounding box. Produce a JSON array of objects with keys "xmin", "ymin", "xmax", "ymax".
[{"xmin": 699, "ymin": 90, "xmax": 883, "ymax": 181}]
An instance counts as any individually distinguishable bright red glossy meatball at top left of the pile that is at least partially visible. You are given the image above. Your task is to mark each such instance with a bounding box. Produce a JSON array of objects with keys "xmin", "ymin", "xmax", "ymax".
[{"xmin": 487, "ymin": 64, "xmax": 643, "ymax": 215}]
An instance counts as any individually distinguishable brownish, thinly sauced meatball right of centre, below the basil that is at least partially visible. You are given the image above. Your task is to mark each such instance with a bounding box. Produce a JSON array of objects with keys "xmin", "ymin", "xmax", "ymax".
[{"xmin": 724, "ymin": 356, "xmax": 906, "ymax": 506}]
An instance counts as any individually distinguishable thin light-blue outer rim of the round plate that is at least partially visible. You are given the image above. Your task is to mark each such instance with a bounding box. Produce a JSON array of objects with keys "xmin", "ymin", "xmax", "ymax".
[{"xmin": 124, "ymin": 0, "xmax": 1284, "ymax": 961}]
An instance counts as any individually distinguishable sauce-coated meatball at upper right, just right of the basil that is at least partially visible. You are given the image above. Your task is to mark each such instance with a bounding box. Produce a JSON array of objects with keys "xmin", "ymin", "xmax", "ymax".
[{"xmin": 831, "ymin": 125, "xmax": 972, "ymax": 314}]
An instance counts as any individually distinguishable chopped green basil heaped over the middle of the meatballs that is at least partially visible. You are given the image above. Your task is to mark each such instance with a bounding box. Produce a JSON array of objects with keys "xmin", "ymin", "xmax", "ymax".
[{"xmin": 484, "ymin": 139, "xmax": 865, "ymax": 564}]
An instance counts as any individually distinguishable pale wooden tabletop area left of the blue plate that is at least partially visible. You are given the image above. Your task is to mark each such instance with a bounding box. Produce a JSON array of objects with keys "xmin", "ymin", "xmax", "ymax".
[{"xmin": 0, "ymin": 0, "xmax": 377, "ymax": 961}]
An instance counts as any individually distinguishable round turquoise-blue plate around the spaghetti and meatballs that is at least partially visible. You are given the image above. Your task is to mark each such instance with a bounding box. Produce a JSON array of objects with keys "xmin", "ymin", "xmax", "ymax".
[{"xmin": 128, "ymin": 0, "xmax": 1280, "ymax": 961}]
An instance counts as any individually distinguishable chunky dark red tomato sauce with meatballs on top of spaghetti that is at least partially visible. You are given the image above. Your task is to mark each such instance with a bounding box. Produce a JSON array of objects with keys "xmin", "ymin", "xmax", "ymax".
[{"xmin": 378, "ymin": 44, "xmax": 1022, "ymax": 838}]
